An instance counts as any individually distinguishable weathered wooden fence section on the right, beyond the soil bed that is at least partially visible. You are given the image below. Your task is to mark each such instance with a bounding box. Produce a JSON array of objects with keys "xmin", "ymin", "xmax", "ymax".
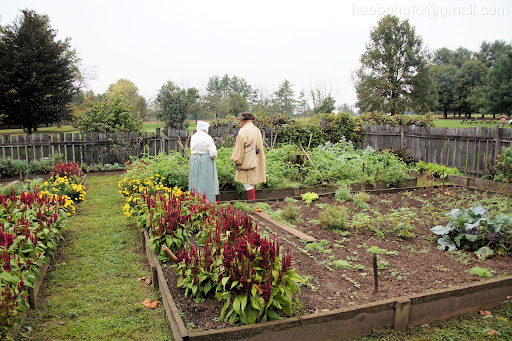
[{"xmin": 362, "ymin": 126, "xmax": 512, "ymax": 173}]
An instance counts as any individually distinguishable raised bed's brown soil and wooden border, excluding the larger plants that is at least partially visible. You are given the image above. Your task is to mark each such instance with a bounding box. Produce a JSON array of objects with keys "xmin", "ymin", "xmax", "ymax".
[{"xmin": 142, "ymin": 187, "xmax": 512, "ymax": 340}]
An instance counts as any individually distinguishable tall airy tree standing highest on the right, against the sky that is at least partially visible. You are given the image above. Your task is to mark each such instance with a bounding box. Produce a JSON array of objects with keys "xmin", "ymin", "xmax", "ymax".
[{"xmin": 355, "ymin": 15, "xmax": 434, "ymax": 115}]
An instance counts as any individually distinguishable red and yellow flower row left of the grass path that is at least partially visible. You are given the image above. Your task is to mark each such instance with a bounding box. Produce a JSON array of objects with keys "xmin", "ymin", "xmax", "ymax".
[{"xmin": 0, "ymin": 163, "xmax": 86, "ymax": 337}]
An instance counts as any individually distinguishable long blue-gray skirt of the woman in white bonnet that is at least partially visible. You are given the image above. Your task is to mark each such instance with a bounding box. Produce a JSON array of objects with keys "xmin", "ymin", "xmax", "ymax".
[{"xmin": 188, "ymin": 154, "xmax": 219, "ymax": 202}]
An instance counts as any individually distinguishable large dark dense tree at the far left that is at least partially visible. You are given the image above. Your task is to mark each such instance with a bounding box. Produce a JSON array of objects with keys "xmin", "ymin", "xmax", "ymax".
[{"xmin": 0, "ymin": 10, "xmax": 78, "ymax": 134}]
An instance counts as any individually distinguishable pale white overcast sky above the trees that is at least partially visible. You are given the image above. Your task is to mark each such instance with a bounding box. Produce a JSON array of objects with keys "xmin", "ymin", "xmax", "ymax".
[{"xmin": 0, "ymin": 0, "xmax": 512, "ymax": 105}]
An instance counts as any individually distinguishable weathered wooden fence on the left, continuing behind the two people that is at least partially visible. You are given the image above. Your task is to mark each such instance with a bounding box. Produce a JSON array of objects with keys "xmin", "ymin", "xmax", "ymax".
[{"xmin": 0, "ymin": 125, "xmax": 273, "ymax": 165}]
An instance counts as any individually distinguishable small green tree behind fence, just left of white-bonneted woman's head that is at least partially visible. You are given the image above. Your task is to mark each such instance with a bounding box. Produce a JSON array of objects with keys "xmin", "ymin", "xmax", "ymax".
[{"xmin": 155, "ymin": 81, "xmax": 199, "ymax": 129}]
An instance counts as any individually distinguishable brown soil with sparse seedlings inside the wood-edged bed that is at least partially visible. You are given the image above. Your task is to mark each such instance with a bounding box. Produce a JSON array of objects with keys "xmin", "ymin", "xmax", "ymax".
[{"xmin": 164, "ymin": 187, "xmax": 512, "ymax": 329}]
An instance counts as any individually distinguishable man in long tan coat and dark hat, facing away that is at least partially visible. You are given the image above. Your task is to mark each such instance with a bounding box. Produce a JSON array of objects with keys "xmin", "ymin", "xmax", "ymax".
[{"xmin": 231, "ymin": 112, "xmax": 267, "ymax": 200}]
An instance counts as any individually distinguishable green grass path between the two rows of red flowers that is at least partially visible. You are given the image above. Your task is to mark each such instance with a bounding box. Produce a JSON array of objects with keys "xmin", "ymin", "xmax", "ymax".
[{"xmin": 21, "ymin": 175, "xmax": 172, "ymax": 340}]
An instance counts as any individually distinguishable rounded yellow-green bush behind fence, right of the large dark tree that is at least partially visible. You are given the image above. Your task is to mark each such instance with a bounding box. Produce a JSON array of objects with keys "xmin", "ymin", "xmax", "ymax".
[{"xmin": 73, "ymin": 94, "xmax": 142, "ymax": 133}]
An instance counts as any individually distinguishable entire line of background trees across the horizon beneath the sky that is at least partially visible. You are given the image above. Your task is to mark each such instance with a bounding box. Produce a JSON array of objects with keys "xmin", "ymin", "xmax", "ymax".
[{"xmin": 0, "ymin": 10, "xmax": 512, "ymax": 133}]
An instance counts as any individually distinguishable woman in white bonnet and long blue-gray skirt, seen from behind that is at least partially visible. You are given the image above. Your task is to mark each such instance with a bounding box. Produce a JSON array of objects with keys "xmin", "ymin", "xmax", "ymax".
[{"xmin": 188, "ymin": 121, "xmax": 219, "ymax": 202}]
